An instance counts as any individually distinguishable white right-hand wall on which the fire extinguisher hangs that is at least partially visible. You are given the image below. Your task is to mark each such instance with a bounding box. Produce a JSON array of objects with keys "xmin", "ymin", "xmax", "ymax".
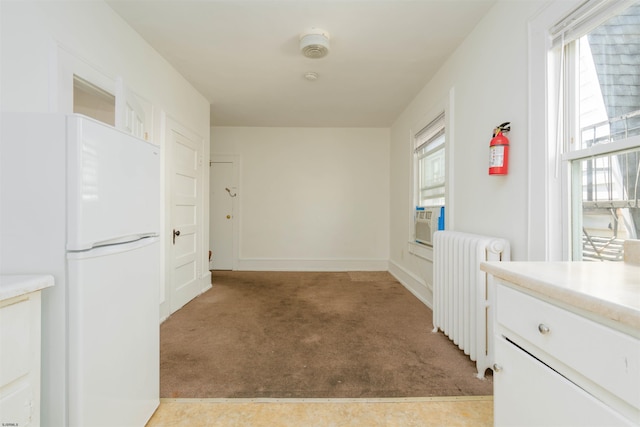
[{"xmin": 390, "ymin": 1, "xmax": 545, "ymax": 303}]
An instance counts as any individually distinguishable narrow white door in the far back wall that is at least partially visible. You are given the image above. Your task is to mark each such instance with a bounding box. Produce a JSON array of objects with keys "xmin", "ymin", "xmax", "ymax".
[{"xmin": 209, "ymin": 160, "xmax": 238, "ymax": 270}]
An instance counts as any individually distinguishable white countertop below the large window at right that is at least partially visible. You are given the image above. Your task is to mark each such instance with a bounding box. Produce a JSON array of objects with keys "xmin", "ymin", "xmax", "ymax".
[{"xmin": 480, "ymin": 262, "xmax": 640, "ymax": 336}]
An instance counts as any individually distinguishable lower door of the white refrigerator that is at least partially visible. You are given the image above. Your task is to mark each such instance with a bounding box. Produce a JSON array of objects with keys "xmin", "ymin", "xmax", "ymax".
[{"xmin": 67, "ymin": 238, "xmax": 160, "ymax": 427}]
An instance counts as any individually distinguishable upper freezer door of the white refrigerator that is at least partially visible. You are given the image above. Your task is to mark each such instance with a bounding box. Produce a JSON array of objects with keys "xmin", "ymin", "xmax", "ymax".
[{"xmin": 66, "ymin": 115, "xmax": 160, "ymax": 251}]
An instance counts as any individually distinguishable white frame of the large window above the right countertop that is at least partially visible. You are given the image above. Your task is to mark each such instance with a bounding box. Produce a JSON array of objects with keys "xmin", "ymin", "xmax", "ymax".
[{"xmin": 527, "ymin": 0, "xmax": 635, "ymax": 261}]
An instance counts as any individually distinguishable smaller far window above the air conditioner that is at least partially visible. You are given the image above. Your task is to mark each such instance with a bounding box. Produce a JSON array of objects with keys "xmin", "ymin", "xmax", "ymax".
[{"xmin": 414, "ymin": 113, "xmax": 446, "ymax": 207}]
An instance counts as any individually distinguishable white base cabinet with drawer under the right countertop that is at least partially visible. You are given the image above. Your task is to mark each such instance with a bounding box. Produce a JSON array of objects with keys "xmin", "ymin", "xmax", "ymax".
[{"xmin": 494, "ymin": 280, "xmax": 640, "ymax": 427}]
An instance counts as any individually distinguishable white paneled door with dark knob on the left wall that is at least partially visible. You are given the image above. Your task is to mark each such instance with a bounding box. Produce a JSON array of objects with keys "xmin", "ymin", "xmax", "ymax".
[{"xmin": 169, "ymin": 129, "xmax": 202, "ymax": 313}]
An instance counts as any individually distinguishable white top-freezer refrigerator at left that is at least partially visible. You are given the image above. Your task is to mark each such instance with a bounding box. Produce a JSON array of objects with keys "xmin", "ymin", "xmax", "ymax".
[{"xmin": 0, "ymin": 113, "xmax": 161, "ymax": 427}]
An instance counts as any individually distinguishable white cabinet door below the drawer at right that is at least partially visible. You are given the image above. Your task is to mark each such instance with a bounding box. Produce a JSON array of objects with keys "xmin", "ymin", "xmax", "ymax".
[{"xmin": 493, "ymin": 336, "xmax": 634, "ymax": 427}]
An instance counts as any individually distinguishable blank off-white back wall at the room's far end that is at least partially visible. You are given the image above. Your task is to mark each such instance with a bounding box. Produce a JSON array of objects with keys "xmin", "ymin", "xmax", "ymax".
[{"xmin": 211, "ymin": 127, "xmax": 389, "ymax": 270}]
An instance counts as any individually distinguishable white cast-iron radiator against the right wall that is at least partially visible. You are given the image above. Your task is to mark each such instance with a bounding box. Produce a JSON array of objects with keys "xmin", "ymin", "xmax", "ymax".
[{"xmin": 433, "ymin": 231, "xmax": 511, "ymax": 378}]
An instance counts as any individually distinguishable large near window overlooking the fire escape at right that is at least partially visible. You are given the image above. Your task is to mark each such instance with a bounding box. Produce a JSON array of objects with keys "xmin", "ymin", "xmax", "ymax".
[{"xmin": 552, "ymin": 1, "xmax": 640, "ymax": 261}]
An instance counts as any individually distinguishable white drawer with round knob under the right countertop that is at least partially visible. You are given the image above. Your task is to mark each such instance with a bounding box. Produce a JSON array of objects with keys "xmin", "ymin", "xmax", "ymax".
[{"xmin": 496, "ymin": 285, "xmax": 640, "ymax": 408}]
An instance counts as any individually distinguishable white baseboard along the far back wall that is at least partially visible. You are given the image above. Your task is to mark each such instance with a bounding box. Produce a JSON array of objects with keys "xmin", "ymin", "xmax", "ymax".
[{"xmin": 235, "ymin": 258, "xmax": 389, "ymax": 271}]
